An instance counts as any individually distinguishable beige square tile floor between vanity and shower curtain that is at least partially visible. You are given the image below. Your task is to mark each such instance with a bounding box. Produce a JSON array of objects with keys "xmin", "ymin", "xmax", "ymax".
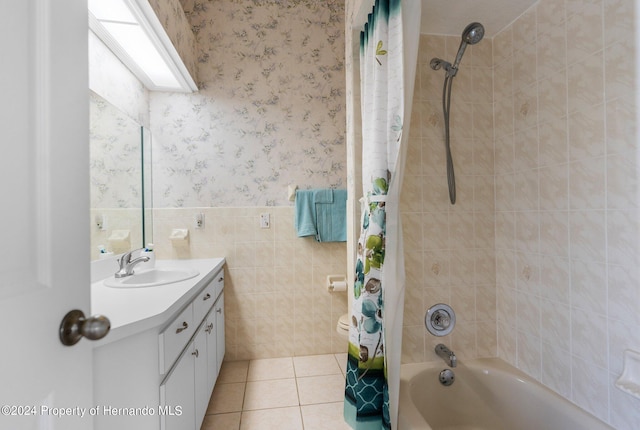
[{"xmin": 201, "ymin": 354, "xmax": 350, "ymax": 430}]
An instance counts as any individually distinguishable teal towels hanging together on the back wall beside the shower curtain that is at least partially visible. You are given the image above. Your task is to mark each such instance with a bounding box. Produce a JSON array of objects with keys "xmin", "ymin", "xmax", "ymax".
[{"xmin": 295, "ymin": 189, "xmax": 347, "ymax": 242}]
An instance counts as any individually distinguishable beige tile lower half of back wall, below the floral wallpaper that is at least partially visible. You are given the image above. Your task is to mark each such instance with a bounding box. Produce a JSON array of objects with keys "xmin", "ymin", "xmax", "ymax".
[{"xmin": 153, "ymin": 207, "xmax": 347, "ymax": 360}]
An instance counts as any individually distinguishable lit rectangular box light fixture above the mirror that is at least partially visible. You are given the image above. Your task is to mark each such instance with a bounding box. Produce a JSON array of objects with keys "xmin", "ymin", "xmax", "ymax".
[{"xmin": 89, "ymin": 0, "xmax": 197, "ymax": 92}]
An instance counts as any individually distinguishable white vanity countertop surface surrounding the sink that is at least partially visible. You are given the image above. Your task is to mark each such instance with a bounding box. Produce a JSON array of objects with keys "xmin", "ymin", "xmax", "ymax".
[{"xmin": 91, "ymin": 258, "xmax": 225, "ymax": 347}]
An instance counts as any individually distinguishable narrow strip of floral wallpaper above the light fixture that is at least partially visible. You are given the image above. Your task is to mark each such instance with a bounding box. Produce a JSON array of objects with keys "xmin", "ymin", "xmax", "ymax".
[{"xmin": 149, "ymin": 0, "xmax": 198, "ymax": 85}]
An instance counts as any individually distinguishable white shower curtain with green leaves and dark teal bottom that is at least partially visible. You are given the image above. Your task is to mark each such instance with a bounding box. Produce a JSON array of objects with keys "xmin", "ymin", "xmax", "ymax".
[{"xmin": 344, "ymin": 0, "xmax": 421, "ymax": 430}]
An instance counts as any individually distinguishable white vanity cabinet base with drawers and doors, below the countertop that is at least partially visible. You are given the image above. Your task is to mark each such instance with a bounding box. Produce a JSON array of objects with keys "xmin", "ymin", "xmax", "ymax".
[{"xmin": 94, "ymin": 259, "xmax": 225, "ymax": 430}]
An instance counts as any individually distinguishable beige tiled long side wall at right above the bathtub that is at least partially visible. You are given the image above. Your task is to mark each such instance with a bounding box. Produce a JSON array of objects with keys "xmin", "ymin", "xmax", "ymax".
[{"xmin": 493, "ymin": 0, "xmax": 640, "ymax": 429}]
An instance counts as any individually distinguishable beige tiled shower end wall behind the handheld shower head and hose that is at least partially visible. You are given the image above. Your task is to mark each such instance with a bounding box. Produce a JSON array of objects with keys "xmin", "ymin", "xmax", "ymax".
[{"xmin": 401, "ymin": 35, "xmax": 497, "ymax": 363}]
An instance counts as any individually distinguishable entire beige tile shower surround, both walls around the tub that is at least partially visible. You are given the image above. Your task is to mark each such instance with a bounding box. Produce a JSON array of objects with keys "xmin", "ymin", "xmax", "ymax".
[{"xmin": 403, "ymin": 0, "xmax": 640, "ymax": 429}]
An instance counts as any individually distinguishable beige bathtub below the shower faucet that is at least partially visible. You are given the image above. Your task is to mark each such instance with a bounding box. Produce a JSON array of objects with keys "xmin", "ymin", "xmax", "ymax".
[{"xmin": 398, "ymin": 358, "xmax": 612, "ymax": 430}]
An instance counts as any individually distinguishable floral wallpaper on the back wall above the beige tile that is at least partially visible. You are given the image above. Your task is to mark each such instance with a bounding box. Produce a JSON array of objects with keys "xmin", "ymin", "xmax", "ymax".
[{"xmin": 150, "ymin": 0, "xmax": 346, "ymax": 208}]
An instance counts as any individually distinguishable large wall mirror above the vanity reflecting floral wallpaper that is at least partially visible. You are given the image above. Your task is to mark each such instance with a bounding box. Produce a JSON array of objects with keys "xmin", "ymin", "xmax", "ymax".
[{"xmin": 89, "ymin": 91, "xmax": 153, "ymax": 260}]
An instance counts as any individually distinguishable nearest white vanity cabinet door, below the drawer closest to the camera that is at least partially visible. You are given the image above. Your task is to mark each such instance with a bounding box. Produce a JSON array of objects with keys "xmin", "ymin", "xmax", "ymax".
[{"xmin": 158, "ymin": 343, "xmax": 196, "ymax": 430}]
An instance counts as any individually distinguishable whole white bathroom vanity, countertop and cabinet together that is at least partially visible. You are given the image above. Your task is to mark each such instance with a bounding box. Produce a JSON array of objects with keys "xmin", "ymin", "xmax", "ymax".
[{"xmin": 91, "ymin": 258, "xmax": 225, "ymax": 430}]
